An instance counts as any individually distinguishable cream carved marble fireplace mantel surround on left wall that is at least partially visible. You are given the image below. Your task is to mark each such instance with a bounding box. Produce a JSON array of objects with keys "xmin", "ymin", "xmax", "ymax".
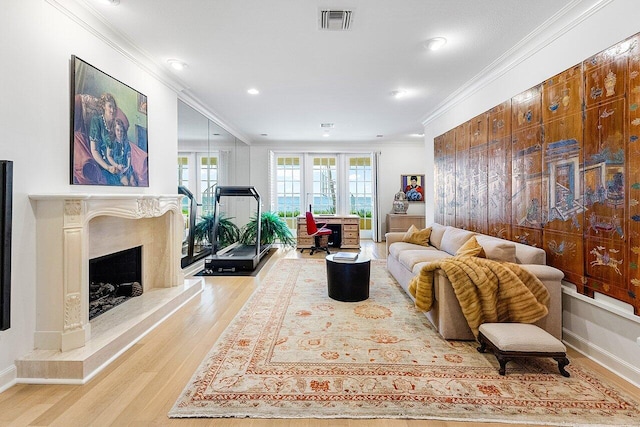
[{"xmin": 29, "ymin": 194, "xmax": 184, "ymax": 352}]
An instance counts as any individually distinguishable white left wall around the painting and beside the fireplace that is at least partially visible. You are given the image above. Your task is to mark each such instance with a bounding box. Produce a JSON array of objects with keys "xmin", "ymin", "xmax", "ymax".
[{"xmin": 0, "ymin": 0, "xmax": 177, "ymax": 391}]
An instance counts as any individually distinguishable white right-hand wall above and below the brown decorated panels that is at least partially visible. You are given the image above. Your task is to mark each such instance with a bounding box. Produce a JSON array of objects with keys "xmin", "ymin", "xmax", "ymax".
[{"xmin": 425, "ymin": 0, "xmax": 640, "ymax": 384}]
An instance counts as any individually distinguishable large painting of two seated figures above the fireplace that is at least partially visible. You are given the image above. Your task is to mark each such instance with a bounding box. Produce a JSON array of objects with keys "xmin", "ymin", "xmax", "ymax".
[{"xmin": 70, "ymin": 56, "xmax": 149, "ymax": 187}]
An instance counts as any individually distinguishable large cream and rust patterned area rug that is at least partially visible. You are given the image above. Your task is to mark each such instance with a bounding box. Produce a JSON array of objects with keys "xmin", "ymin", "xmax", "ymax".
[{"xmin": 169, "ymin": 259, "xmax": 640, "ymax": 425}]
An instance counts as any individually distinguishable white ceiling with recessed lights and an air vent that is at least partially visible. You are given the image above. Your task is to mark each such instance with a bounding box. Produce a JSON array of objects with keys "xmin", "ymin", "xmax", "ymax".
[{"xmin": 75, "ymin": 0, "xmax": 594, "ymax": 143}]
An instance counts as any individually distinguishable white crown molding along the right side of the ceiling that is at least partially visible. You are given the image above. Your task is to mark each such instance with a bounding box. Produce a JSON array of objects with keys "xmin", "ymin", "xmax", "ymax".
[{"xmin": 421, "ymin": 0, "xmax": 613, "ymax": 126}]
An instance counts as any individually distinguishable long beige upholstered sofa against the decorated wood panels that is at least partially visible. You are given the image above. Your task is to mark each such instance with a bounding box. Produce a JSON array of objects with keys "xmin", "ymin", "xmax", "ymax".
[{"xmin": 385, "ymin": 223, "xmax": 564, "ymax": 340}]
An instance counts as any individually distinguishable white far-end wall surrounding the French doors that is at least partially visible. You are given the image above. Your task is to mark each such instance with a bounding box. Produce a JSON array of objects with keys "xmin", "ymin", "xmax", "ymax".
[{"xmin": 251, "ymin": 141, "xmax": 424, "ymax": 240}]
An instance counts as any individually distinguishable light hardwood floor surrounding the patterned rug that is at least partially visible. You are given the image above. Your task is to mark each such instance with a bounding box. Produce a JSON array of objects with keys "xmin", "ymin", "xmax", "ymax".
[{"xmin": 0, "ymin": 240, "xmax": 640, "ymax": 427}]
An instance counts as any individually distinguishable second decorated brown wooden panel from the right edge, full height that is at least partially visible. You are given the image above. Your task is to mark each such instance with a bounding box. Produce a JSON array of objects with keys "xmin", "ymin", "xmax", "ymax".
[{"xmin": 583, "ymin": 39, "xmax": 628, "ymax": 300}]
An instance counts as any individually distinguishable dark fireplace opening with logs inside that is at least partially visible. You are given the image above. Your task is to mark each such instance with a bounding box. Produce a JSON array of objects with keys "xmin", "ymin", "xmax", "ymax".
[{"xmin": 89, "ymin": 246, "xmax": 142, "ymax": 320}]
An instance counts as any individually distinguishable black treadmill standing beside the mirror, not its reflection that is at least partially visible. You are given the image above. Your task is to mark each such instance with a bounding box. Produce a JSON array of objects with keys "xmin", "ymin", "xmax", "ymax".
[{"xmin": 204, "ymin": 185, "xmax": 271, "ymax": 273}]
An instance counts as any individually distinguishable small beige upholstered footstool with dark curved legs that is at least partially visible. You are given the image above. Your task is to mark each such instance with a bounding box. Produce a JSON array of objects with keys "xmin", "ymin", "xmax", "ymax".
[{"xmin": 478, "ymin": 323, "xmax": 569, "ymax": 377}]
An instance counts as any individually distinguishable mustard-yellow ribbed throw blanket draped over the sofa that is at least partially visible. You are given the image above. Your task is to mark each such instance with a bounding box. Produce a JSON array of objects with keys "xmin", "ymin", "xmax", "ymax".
[{"xmin": 409, "ymin": 256, "xmax": 549, "ymax": 337}]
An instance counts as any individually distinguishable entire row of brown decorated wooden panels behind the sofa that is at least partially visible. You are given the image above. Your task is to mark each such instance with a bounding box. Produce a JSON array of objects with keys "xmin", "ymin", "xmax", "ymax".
[{"xmin": 436, "ymin": 34, "xmax": 640, "ymax": 314}]
